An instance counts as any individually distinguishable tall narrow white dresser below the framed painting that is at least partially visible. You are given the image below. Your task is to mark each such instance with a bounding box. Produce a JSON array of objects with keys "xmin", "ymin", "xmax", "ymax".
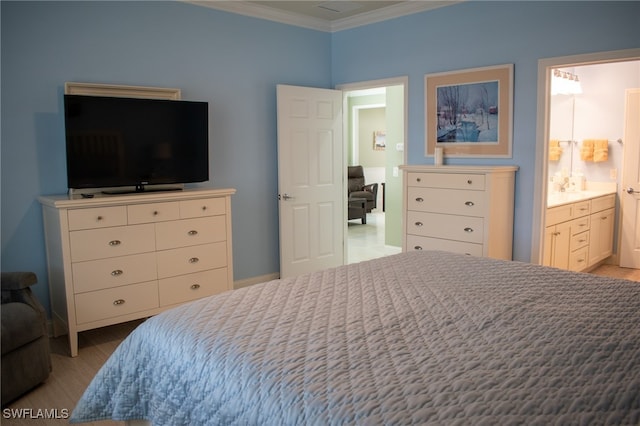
[{"xmin": 401, "ymin": 166, "xmax": 518, "ymax": 259}]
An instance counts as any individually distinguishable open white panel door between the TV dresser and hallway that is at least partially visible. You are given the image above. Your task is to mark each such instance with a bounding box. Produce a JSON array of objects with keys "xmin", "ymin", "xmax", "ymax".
[{"xmin": 277, "ymin": 85, "xmax": 345, "ymax": 278}]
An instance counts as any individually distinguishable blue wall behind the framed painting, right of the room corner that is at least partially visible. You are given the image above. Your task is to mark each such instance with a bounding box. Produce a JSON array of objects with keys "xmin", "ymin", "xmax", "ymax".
[{"xmin": 331, "ymin": 1, "xmax": 640, "ymax": 261}]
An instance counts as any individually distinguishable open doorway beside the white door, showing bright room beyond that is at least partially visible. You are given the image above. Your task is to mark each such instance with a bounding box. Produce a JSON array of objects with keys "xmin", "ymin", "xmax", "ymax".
[{"xmin": 338, "ymin": 77, "xmax": 407, "ymax": 263}]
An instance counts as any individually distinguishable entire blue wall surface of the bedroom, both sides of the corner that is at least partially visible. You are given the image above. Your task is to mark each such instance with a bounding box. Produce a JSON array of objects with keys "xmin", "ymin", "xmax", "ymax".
[{"xmin": 0, "ymin": 1, "xmax": 640, "ymax": 316}]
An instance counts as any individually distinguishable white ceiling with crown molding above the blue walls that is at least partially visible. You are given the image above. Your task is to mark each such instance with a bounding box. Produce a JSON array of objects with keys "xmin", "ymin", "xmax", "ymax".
[{"xmin": 186, "ymin": 0, "xmax": 464, "ymax": 32}]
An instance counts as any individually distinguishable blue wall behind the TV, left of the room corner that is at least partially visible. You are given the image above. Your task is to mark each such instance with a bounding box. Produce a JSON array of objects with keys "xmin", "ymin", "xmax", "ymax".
[{"xmin": 1, "ymin": 1, "xmax": 331, "ymax": 312}]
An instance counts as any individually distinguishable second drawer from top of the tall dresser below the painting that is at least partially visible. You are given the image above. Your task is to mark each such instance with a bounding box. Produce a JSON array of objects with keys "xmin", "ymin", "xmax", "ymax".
[{"xmin": 407, "ymin": 186, "xmax": 485, "ymax": 216}]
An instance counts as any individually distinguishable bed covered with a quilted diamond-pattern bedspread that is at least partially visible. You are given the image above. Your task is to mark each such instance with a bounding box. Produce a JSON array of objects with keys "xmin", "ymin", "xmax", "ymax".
[{"xmin": 71, "ymin": 251, "xmax": 640, "ymax": 426}]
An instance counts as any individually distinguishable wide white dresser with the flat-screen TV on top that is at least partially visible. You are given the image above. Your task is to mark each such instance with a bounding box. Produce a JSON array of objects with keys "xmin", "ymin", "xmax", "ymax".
[{"xmin": 39, "ymin": 189, "xmax": 235, "ymax": 356}]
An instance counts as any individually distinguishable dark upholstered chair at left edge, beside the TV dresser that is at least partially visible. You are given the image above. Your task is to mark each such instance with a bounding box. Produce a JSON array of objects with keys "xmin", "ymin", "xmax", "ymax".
[{"xmin": 0, "ymin": 272, "xmax": 51, "ymax": 407}]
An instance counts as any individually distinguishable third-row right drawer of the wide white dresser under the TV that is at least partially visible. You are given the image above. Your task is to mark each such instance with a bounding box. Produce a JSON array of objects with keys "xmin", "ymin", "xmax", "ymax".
[{"xmin": 158, "ymin": 241, "xmax": 227, "ymax": 278}]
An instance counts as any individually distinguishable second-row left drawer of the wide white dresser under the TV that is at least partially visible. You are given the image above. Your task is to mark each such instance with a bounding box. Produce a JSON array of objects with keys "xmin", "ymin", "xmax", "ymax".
[{"xmin": 69, "ymin": 224, "xmax": 156, "ymax": 262}]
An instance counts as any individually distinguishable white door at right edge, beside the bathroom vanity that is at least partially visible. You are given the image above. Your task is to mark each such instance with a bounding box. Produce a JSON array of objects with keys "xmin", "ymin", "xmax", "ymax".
[{"xmin": 620, "ymin": 89, "xmax": 640, "ymax": 269}]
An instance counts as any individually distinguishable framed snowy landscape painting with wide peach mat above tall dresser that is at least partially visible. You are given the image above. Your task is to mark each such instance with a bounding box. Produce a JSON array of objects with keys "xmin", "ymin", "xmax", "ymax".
[{"xmin": 424, "ymin": 64, "xmax": 513, "ymax": 158}]
